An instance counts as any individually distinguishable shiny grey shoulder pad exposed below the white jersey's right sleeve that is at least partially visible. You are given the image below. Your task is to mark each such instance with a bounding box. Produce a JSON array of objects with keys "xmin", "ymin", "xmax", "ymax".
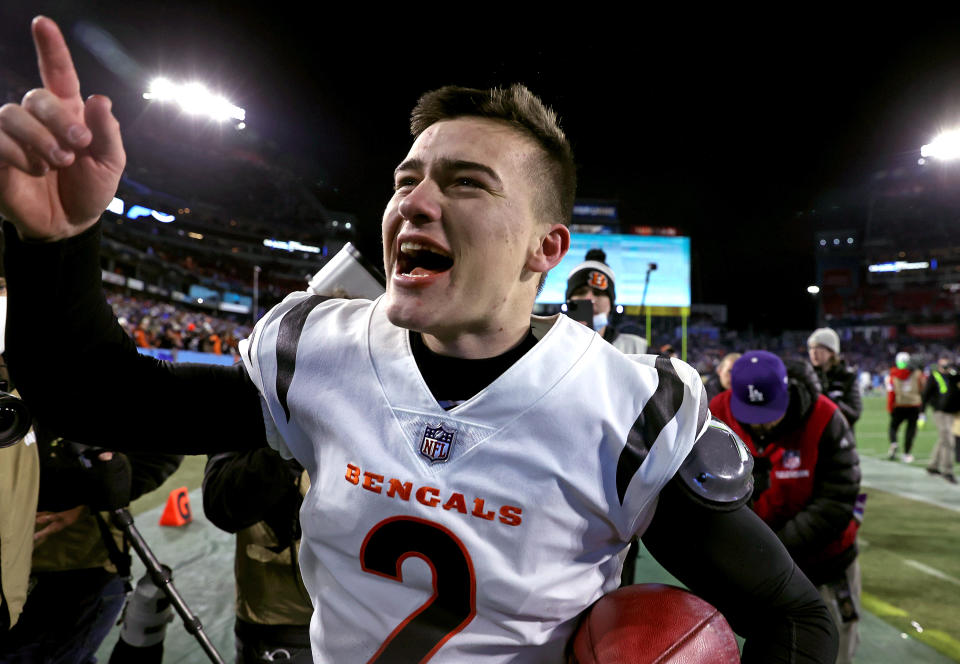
[{"xmin": 675, "ymin": 418, "xmax": 753, "ymax": 510}]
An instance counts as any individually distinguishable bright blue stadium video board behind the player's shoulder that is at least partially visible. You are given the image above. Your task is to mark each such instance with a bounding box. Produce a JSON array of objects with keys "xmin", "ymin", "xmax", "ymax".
[{"xmin": 537, "ymin": 233, "xmax": 690, "ymax": 307}]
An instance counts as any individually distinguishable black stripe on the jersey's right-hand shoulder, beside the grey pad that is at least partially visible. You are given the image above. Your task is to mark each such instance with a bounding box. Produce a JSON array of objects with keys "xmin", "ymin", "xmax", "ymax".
[{"xmin": 617, "ymin": 357, "xmax": 688, "ymax": 505}]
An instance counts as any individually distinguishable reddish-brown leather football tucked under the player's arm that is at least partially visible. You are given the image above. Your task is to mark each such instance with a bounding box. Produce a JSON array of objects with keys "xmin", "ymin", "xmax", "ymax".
[{"xmin": 573, "ymin": 583, "xmax": 740, "ymax": 664}]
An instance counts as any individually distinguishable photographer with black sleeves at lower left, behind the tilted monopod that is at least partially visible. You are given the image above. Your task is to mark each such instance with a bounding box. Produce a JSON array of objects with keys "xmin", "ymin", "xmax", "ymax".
[{"xmin": 0, "ymin": 427, "xmax": 182, "ymax": 662}]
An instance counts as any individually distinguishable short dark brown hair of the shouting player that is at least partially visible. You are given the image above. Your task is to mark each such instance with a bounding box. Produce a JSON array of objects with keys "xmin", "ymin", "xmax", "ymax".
[{"xmin": 410, "ymin": 83, "xmax": 577, "ymax": 225}]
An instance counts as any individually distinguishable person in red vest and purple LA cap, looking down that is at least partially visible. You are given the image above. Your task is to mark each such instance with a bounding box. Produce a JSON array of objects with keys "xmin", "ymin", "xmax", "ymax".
[{"xmin": 710, "ymin": 351, "xmax": 861, "ymax": 663}]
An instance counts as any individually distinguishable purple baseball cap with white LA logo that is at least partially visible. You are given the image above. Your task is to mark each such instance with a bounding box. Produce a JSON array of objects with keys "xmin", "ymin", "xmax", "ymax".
[{"xmin": 730, "ymin": 350, "xmax": 790, "ymax": 424}]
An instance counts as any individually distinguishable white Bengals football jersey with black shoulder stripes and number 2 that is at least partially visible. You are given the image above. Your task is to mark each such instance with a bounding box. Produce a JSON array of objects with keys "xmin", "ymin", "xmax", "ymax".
[{"xmin": 242, "ymin": 293, "xmax": 707, "ymax": 664}]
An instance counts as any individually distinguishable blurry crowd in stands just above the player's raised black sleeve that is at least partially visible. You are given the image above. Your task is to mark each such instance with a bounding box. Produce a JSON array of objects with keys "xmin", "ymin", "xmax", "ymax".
[{"xmin": 107, "ymin": 293, "xmax": 252, "ymax": 355}]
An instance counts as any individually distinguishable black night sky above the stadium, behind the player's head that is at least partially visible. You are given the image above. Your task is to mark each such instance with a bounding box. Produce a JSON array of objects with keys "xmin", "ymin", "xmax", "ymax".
[{"xmin": 0, "ymin": 1, "xmax": 960, "ymax": 329}]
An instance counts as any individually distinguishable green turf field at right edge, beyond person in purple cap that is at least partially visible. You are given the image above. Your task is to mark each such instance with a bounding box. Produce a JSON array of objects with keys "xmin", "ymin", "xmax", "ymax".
[{"xmin": 856, "ymin": 396, "xmax": 960, "ymax": 661}]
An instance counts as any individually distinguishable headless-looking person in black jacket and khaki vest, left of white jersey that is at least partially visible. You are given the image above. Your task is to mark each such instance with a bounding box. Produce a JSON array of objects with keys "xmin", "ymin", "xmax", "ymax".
[{"xmin": 203, "ymin": 447, "xmax": 313, "ymax": 664}]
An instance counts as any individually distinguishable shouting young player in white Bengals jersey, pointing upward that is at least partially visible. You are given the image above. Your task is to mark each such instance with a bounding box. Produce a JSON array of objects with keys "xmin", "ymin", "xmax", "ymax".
[{"xmin": 0, "ymin": 17, "xmax": 836, "ymax": 663}]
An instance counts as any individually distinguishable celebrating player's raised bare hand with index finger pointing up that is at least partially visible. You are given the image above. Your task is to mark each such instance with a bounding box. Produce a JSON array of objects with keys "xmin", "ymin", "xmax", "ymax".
[{"xmin": 0, "ymin": 16, "xmax": 126, "ymax": 240}]
